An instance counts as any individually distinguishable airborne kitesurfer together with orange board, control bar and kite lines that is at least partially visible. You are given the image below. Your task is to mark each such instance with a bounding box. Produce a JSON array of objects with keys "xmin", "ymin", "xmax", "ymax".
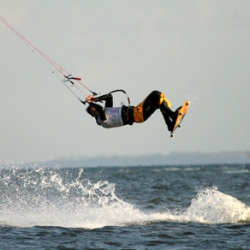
[{"xmin": 0, "ymin": 16, "xmax": 189, "ymax": 134}]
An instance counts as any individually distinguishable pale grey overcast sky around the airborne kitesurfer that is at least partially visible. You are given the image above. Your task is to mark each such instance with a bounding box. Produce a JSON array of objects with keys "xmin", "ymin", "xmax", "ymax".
[{"xmin": 0, "ymin": 0, "xmax": 250, "ymax": 162}]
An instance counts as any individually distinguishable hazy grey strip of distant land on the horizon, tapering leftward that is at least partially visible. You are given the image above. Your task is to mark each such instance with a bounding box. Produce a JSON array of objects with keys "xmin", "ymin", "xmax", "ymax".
[{"xmin": 47, "ymin": 151, "xmax": 250, "ymax": 167}]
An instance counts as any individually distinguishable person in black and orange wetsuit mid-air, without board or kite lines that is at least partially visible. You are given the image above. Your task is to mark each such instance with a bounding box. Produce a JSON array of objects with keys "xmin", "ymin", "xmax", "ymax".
[{"xmin": 86, "ymin": 90, "xmax": 182, "ymax": 131}]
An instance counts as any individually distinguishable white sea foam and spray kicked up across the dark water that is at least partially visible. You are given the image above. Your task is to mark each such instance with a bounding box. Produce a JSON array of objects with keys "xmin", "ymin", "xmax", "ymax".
[{"xmin": 0, "ymin": 169, "xmax": 250, "ymax": 229}]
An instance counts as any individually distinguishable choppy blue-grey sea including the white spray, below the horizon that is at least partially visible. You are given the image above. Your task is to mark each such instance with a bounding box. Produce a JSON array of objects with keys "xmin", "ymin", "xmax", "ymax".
[{"xmin": 0, "ymin": 163, "xmax": 250, "ymax": 250}]
